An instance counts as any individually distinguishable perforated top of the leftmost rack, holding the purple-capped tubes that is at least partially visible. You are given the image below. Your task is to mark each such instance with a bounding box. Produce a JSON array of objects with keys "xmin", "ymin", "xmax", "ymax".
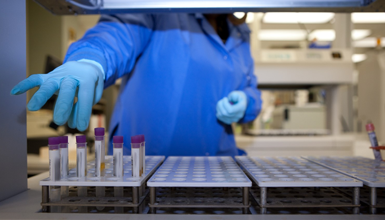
[{"xmin": 40, "ymin": 156, "xmax": 165, "ymax": 187}]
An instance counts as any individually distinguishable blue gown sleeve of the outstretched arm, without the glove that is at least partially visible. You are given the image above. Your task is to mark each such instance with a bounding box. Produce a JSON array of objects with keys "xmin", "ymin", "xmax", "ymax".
[{"xmin": 64, "ymin": 14, "xmax": 154, "ymax": 87}]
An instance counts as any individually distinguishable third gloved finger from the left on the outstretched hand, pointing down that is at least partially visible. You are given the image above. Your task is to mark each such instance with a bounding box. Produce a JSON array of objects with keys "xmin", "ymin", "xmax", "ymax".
[{"xmin": 53, "ymin": 77, "xmax": 78, "ymax": 125}]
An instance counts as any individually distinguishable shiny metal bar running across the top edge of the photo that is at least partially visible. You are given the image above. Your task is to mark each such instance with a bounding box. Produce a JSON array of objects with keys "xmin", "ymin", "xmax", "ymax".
[{"xmin": 35, "ymin": 0, "xmax": 385, "ymax": 15}]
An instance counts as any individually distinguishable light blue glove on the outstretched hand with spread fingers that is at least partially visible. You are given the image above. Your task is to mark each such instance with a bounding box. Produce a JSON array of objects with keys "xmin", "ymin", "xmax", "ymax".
[{"xmin": 11, "ymin": 59, "xmax": 104, "ymax": 131}]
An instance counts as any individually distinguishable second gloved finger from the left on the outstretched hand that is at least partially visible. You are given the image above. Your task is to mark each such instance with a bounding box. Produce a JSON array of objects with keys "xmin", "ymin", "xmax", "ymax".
[{"xmin": 27, "ymin": 79, "xmax": 59, "ymax": 111}]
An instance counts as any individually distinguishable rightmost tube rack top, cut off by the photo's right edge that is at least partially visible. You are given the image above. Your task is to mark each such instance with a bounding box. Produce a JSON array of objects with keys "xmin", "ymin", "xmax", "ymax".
[{"xmin": 303, "ymin": 156, "xmax": 385, "ymax": 187}]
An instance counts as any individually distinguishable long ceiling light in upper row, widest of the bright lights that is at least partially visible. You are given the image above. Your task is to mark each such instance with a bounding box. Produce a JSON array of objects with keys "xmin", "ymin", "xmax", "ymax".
[{"xmin": 263, "ymin": 12, "xmax": 334, "ymax": 24}]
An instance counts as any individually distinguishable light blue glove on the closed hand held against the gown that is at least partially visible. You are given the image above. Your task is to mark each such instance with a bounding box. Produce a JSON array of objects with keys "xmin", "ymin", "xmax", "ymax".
[{"xmin": 217, "ymin": 91, "xmax": 247, "ymax": 124}]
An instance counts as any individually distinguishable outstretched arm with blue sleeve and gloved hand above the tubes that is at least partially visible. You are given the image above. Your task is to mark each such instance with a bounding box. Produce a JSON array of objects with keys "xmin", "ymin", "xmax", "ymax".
[{"xmin": 11, "ymin": 14, "xmax": 154, "ymax": 131}]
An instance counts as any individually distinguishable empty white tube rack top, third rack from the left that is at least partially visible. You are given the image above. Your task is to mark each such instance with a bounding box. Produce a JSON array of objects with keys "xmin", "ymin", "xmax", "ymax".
[{"xmin": 235, "ymin": 156, "xmax": 363, "ymax": 187}]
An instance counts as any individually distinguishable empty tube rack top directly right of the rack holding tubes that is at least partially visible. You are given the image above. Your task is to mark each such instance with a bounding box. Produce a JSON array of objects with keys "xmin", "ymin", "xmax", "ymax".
[{"xmin": 147, "ymin": 157, "xmax": 251, "ymax": 187}]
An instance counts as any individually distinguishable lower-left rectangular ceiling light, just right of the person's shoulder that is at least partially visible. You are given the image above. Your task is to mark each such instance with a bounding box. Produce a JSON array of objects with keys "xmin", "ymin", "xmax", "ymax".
[{"xmin": 258, "ymin": 29, "xmax": 306, "ymax": 41}]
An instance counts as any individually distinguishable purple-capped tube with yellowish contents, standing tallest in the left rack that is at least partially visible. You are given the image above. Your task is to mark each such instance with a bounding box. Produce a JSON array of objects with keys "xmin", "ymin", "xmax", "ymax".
[{"xmin": 94, "ymin": 128, "xmax": 106, "ymax": 210}]
